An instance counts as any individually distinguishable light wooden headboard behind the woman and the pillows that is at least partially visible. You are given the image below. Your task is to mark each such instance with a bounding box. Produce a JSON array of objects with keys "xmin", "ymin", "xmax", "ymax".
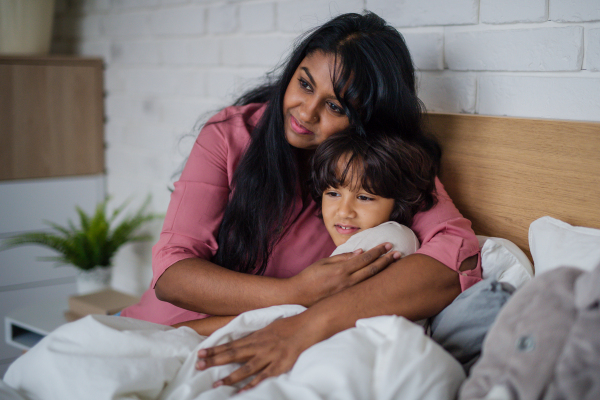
[{"xmin": 428, "ymin": 113, "xmax": 600, "ymax": 258}]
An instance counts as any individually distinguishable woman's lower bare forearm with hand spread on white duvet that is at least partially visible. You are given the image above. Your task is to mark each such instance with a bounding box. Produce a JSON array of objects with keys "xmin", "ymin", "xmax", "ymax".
[{"xmin": 197, "ymin": 254, "xmax": 460, "ymax": 389}]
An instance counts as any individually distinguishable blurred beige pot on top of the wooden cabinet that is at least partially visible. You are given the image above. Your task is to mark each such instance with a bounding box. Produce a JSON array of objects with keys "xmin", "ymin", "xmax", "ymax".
[{"xmin": 0, "ymin": 0, "xmax": 54, "ymax": 54}]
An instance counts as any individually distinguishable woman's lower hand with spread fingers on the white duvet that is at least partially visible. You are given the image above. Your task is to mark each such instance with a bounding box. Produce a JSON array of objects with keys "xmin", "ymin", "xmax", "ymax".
[{"xmin": 196, "ymin": 313, "xmax": 324, "ymax": 391}]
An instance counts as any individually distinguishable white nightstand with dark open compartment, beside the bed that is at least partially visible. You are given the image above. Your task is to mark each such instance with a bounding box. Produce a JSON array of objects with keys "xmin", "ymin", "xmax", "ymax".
[{"xmin": 4, "ymin": 298, "xmax": 69, "ymax": 350}]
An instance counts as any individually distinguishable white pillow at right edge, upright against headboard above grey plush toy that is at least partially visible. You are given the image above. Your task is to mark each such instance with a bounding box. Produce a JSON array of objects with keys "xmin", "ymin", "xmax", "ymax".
[{"xmin": 529, "ymin": 217, "xmax": 600, "ymax": 274}]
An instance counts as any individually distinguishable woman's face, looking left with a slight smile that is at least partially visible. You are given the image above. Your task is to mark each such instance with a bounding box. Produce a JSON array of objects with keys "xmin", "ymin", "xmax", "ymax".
[{"xmin": 283, "ymin": 51, "xmax": 350, "ymax": 149}]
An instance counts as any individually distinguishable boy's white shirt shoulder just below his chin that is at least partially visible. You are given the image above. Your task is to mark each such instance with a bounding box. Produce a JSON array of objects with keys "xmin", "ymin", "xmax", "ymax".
[{"xmin": 331, "ymin": 221, "xmax": 420, "ymax": 257}]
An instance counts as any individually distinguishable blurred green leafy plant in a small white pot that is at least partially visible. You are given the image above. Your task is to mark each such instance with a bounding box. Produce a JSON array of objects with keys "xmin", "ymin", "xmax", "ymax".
[{"xmin": 0, "ymin": 196, "xmax": 159, "ymax": 294}]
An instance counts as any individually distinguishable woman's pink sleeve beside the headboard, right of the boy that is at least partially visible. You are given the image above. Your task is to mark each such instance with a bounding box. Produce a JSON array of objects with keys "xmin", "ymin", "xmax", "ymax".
[{"xmin": 411, "ymin": 178, "xmax": 481, "ymax": 291}]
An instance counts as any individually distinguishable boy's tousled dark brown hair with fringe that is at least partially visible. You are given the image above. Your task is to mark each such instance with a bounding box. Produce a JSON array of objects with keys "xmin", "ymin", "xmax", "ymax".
[{"xmin": 311, "ymin": 128, "xmax": 436, "ymax": 227}]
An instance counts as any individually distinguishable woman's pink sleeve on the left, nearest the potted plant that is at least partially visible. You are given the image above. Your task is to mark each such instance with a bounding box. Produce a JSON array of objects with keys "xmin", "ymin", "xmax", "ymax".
[{"xmin": 151, "ymin": 109, "xmax": 249, "ymax": 287}]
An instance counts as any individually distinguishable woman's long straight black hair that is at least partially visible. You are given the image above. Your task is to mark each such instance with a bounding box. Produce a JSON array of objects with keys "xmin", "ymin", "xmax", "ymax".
[{"xmin": 213, "ymin": 12, "xmax": 441, "ymax": 274}]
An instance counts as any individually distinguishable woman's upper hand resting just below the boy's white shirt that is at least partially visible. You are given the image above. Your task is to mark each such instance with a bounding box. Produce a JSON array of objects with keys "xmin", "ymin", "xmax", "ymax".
[{"xmin": 289, "ymin": 243, "xmax": 401, "ymax": 307}]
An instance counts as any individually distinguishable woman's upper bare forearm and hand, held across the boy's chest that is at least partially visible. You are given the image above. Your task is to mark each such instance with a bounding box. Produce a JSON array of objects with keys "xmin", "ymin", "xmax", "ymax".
[{"xmin": 155, "ymin": 244, "xmax": 400, "ymax": 315}]
